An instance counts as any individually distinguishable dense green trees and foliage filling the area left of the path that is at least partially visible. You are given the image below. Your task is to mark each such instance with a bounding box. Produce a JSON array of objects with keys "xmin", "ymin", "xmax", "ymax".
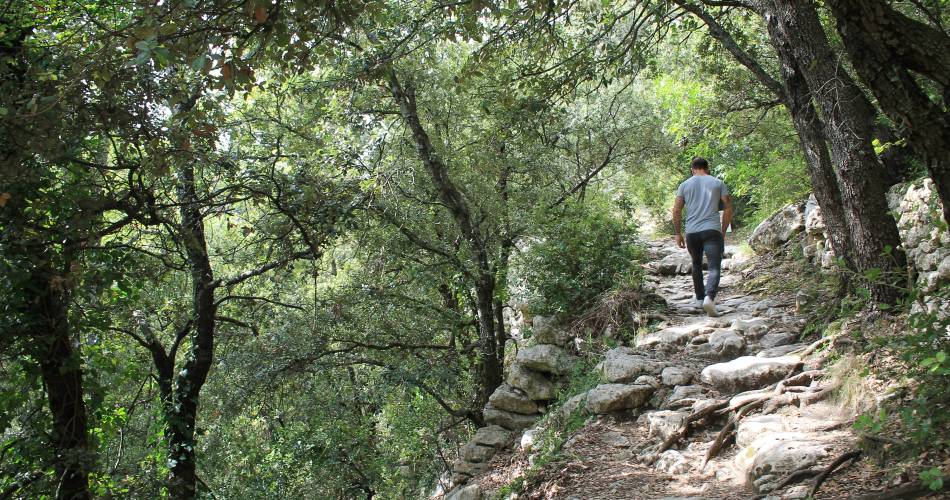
[{"xmin": 0, "ymin": 0, "xmax": 950, "ymax": 498}]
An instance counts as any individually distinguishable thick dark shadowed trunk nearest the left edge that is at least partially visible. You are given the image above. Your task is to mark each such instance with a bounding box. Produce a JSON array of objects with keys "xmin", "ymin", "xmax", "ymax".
[{"xmin": 35, "ymin": 264, "xmax": 93, "ymax": 500}]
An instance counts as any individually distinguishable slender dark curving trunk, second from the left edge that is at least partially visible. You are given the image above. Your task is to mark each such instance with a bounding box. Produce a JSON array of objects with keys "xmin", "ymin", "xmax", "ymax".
[{"xmin": 166, "ymin": 163, "xmax": 216, "ymax": 498}]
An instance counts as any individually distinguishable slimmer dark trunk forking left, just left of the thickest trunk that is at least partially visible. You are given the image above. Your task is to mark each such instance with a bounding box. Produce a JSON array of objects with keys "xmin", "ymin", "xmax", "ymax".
[{"xmin": 674, "ymin": 0, "xmax": 854, "ymax": 269}]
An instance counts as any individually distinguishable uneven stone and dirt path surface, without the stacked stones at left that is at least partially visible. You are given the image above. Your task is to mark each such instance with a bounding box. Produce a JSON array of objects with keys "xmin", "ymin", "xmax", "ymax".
[{"xmin": 447, "ymin": 238, "xmax": 900, "ymax": 500}]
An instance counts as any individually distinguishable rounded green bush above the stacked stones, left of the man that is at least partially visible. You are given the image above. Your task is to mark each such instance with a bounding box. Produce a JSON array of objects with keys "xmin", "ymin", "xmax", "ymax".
[{"xmin": 518, "ymin": 200, "xmax": 643, "ymax": 316}]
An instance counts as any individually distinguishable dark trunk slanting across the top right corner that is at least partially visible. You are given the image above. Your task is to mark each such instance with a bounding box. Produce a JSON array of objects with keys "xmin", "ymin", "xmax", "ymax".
[{"xmin": 828, "ymin": 0, "xmax": 950, "ymax": 225}]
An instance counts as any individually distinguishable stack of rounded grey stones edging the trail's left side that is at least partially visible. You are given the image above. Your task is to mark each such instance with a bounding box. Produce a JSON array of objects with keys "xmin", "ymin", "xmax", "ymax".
[{"xmin": 450, "ymin": 316, "xmax": 576, "ymax": 493}]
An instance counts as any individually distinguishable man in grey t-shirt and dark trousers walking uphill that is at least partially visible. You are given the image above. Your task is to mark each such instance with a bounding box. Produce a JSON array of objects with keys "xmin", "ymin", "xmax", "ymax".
[{"xmin": 673, "ymin": 157, "xmax": 732, "ymax": 316}]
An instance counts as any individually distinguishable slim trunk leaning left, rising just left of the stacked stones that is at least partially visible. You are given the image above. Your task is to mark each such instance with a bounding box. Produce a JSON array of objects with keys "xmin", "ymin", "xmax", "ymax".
[{"xmin": 388, "ymin": 70, "xmax": 505, "ymax": 411}]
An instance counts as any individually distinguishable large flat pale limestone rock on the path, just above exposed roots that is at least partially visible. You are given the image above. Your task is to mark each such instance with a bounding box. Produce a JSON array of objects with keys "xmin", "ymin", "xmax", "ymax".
[{"xmin": 700, "ymin": 356, "xmax": 801, "ymax": 393}]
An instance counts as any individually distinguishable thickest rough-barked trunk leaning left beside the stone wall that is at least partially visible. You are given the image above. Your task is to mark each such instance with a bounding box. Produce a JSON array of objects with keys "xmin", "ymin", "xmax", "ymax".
[{"xmin": 762, "ymin": 0, "xmax": 904, "ymax": 304}]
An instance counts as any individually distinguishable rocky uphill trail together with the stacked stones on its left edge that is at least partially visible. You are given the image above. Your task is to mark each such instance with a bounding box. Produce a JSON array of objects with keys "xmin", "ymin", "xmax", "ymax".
[{"xmin": 436, "ymin": 236, "xmax": 916, "ymax": 500}]
